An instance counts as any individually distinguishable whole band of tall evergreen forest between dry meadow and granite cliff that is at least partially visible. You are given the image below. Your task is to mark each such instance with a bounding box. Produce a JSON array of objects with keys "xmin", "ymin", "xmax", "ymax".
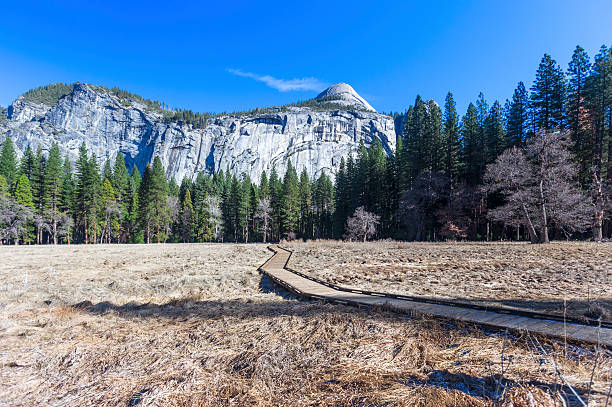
[{"xmin": 0, "ymin": 46, "xmax": 612, "ymax": 244}]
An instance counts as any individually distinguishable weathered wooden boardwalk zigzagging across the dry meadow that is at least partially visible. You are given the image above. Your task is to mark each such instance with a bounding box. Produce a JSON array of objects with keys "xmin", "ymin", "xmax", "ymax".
[{"xmin": 260, "ymin": 246, "xmax": 612, "ymax": 348}]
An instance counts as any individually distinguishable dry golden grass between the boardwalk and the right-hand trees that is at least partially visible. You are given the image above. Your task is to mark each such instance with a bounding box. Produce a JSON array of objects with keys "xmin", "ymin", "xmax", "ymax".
[{"xmin": 287, "ymin": 242, "xmax": 612, "ymax": 320}]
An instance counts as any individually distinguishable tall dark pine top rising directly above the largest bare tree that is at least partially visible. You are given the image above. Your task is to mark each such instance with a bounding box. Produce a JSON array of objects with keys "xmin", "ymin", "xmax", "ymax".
[{"xmin": 531, "ymin": 54, "xmax": 566, "ymax": 130}]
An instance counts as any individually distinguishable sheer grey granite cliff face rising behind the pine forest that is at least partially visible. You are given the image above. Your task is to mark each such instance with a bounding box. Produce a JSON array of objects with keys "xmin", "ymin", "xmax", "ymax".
[{"xmin": 0, "ymin": 84, "xmax": 395, "ymax": 181}]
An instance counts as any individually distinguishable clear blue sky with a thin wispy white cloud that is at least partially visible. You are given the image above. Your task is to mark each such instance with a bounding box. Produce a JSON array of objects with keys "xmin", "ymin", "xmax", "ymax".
[{"xmin": 0, "ymin": 0, "xmax": 612, "ymax": 114}]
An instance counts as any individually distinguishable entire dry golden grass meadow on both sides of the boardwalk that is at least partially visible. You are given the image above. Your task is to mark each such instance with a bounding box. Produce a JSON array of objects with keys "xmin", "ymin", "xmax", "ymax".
[{"xmin": 0, "ymin": 243, "xmax": 612, "ymax": 407}]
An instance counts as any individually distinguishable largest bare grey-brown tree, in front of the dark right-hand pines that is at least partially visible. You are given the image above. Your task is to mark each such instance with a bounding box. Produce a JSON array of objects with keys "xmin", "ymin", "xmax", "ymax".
[{"xmin": 484, "ymin": 131, "xmax": 590, "ymax": 243}]
